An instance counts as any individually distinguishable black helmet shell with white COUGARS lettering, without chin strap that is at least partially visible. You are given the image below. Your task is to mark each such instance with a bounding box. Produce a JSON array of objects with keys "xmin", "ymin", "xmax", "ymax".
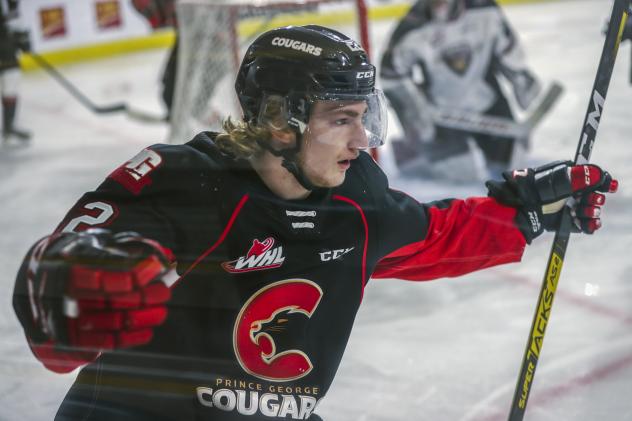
[{"xmin": 235, "ymin": 25, "xmax": 385, "ymax": 146}]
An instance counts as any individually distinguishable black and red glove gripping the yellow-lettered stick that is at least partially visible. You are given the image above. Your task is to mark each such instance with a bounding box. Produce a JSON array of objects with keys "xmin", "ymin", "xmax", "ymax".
[{"xmin": 485, "ymin": 161, "xmax": 618, "ymax": 243}]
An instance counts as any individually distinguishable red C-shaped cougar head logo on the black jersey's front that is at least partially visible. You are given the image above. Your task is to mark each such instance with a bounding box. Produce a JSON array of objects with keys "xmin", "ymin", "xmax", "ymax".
[{"xmin": 233, "ymin": 279, "xmax": 323, "ymax": 381}]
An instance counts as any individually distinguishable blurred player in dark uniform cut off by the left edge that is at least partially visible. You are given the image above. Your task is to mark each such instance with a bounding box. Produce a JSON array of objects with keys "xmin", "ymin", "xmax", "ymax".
[{"xmin": 0, "ymin": 0, "xmax": 31, "ymax": 142}]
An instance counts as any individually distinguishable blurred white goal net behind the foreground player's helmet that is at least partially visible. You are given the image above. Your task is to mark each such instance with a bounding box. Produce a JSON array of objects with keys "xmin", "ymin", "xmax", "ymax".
[{"xmin": 169, "ymin": 0, "xmax": 370, "ymax": 143}]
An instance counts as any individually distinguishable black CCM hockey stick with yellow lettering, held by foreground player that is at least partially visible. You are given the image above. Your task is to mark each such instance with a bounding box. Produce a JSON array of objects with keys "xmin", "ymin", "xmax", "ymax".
[{"xmin": 509, "ymin": 0, "xmax": 630, "ymax": 421}]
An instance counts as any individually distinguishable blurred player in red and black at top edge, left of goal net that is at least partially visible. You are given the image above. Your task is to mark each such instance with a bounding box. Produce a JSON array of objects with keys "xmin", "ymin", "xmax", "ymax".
[{"xmin": 132, "ymin": 0, "xmax": 178, "ymax": 121}]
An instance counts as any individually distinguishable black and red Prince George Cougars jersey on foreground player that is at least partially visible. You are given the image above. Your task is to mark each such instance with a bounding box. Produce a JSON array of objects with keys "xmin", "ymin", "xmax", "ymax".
[{"xmin": 19, "ymin": 133, "xmax": 525, "ymax": 420}]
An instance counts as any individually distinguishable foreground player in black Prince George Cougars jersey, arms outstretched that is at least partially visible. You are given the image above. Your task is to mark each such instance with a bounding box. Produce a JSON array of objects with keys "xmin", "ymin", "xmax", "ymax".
[{"xmin": 13, "ymin": 25, "xmax": 616, "ymax": 421}]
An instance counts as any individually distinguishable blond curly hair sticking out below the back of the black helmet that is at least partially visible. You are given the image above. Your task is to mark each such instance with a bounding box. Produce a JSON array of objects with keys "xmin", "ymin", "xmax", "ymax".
[{"xmin": 215, "ymin": 95, "xmax": 290, "ymax": 159}]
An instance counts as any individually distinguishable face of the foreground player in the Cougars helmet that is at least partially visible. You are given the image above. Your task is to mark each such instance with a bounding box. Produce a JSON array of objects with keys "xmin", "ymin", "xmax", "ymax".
[{"xmin": 299, "ymin": 101, "xmax": 369, "ymax": 187}]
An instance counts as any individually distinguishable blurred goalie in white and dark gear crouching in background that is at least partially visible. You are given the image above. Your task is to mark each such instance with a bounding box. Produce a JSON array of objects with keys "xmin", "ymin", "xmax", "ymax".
[{"xmin": 380, "ymin": 0, "xmax": 540, "ymax": 180}]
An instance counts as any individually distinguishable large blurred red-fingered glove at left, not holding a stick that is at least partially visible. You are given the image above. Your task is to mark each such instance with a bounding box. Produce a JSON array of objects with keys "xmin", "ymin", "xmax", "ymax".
[{"xmin": 13, "ymin": 229, "xmax": 173, "ymax": 368}]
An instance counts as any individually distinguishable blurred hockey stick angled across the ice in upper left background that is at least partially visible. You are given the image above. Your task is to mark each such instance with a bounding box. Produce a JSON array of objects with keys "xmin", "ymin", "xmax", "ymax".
[{"xmin": 29, "ymin": 51, "xmax": 166, "ymax": 122}]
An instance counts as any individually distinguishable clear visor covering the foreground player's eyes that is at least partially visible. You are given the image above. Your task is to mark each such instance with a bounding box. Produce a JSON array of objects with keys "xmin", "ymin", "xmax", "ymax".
[{"xmin": 259, "ymin": 89, "xmax": 388, "ymax": 149}]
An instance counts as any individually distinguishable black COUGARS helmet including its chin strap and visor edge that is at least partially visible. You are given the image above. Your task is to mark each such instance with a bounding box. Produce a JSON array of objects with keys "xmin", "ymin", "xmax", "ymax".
[{"xmin": 235, "ymin": 25, "xmax": 387, "ymax": 190}]
